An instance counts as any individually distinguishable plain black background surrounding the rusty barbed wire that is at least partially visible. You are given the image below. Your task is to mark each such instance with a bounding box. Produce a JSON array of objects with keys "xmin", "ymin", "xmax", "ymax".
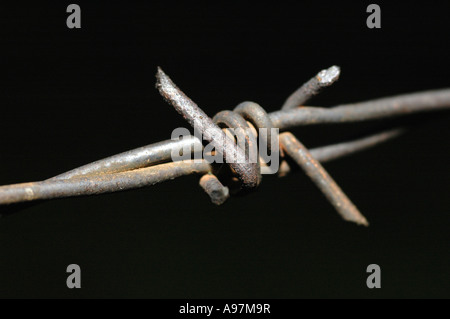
[{"xmin": 0, "ymin": 1, "xmax": 450, "ymax": 298}]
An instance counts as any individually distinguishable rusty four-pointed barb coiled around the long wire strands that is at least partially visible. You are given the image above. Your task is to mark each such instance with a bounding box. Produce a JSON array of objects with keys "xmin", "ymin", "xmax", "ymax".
[{"xmin": 157, "ymin": 68, "xmax": 368, "ymax": 226}]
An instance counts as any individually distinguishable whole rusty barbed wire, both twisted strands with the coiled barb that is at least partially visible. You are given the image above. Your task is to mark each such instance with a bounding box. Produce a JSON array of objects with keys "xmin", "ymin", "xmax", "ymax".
[{"xmin": 0, "ymin": 66, "xmax": 450, "ymax": 226}]
